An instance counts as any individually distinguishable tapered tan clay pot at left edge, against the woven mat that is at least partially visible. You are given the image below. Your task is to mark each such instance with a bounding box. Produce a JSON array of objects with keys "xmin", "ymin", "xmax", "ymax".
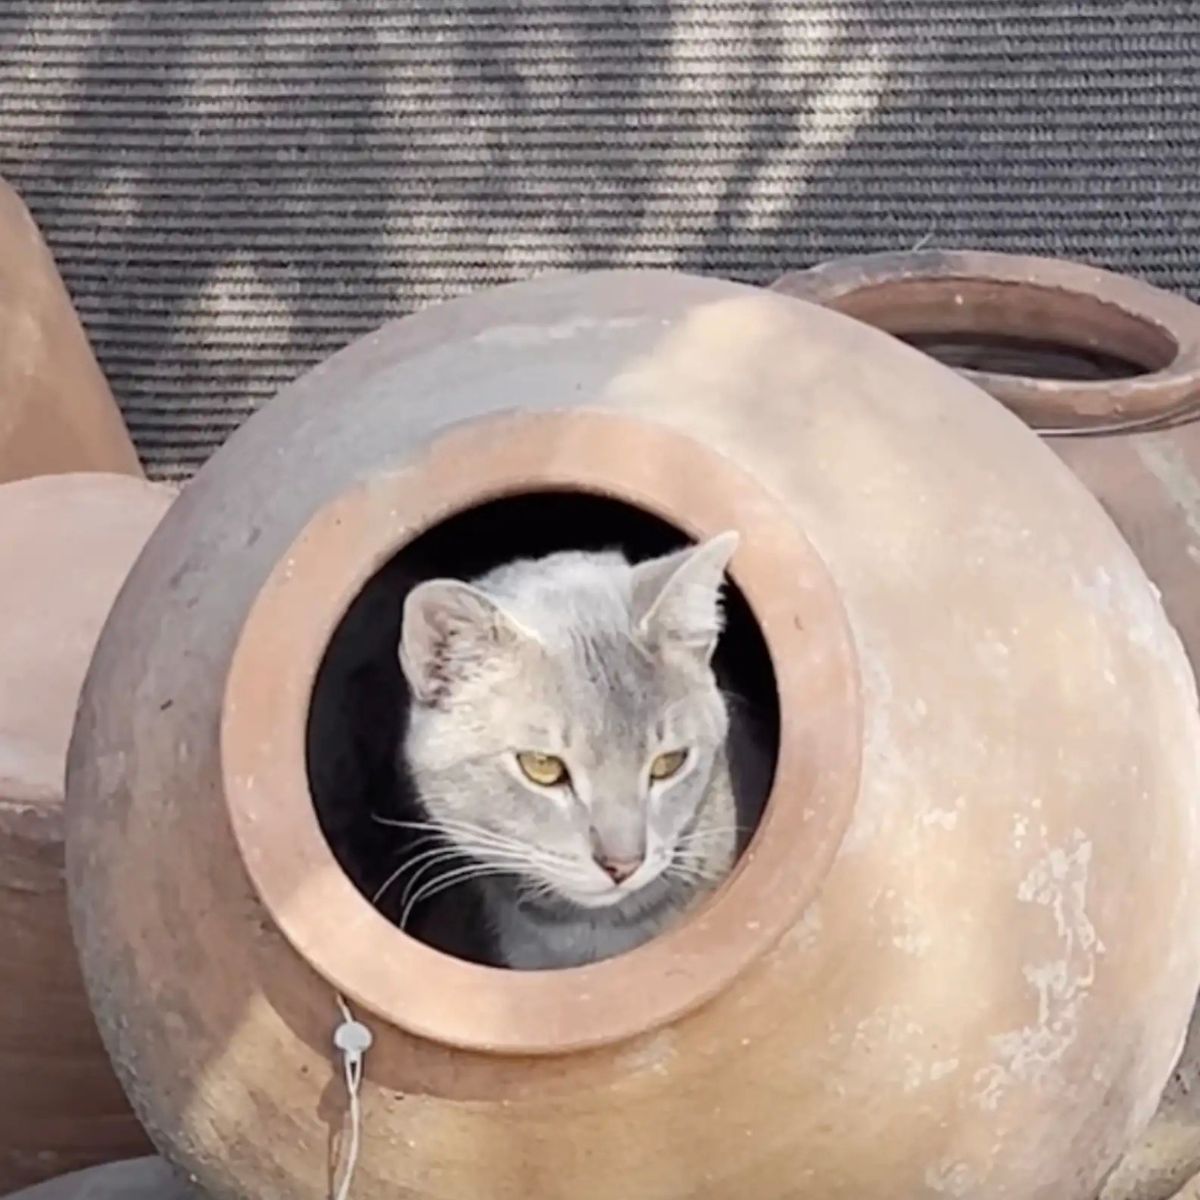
[{"xmin": 0, "ymin": 179, "xmax": 142, "ymax": 484}]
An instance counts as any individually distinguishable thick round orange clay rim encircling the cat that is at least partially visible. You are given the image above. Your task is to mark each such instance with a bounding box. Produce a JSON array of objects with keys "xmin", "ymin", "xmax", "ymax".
[{"xmin": 220, "ymin": 409, "xmax": 863, "ymax": 1055}]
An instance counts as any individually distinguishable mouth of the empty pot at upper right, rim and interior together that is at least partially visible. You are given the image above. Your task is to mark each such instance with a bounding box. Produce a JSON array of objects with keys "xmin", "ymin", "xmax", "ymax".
[{"xmin": 773, "ymin": 251, "xmax": 1200, "ymax": 434}]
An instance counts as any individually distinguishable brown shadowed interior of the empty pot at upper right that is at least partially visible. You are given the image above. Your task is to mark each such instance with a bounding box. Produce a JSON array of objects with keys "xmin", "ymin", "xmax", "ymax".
[{"xmin": 832, "ymin": 278, "xmax": 1178, "ymax": 382}]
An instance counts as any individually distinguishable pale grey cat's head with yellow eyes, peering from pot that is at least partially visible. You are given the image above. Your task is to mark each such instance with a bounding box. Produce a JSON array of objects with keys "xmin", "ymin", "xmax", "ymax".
[{"xmin": 400, "ymin": 533, "xmax": 738, "ymax": 908}]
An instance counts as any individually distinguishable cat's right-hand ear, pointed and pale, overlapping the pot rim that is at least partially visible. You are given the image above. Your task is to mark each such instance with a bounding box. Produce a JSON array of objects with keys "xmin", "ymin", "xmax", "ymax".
[{"xmin": 632, "ymin": 532, "xmax": 738, "ymax": 662}]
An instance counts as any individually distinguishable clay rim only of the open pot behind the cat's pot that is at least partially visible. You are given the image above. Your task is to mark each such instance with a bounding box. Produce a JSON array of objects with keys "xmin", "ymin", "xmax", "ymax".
[{"xmin": 770, "ymin": 250, "xmax": 1200, "ymax": 434}]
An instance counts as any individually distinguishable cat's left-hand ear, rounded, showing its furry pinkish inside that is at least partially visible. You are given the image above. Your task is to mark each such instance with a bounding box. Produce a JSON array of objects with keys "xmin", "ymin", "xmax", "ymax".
[{"xmin": 400, "ymin": 580, "xmax": 524, "ymax": 704}]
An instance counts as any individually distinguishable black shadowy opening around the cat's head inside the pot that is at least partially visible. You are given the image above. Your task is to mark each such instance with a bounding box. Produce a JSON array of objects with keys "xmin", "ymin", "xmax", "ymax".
[{"xmin": 307, "ymin": 492, "xmax": 780, "ymax": 965}]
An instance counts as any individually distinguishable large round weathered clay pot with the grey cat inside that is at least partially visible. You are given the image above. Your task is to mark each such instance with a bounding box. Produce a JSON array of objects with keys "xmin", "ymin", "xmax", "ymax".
[{"xmin": 67, "ymin": 272, "xmax": 1200, "ymax": 1200}]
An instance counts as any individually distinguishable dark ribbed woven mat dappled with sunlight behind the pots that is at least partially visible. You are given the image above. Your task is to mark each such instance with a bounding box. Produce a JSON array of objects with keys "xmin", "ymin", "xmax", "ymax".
[{"xmin": 0, "ymin": 0, "xmax": 1200, "ymax": 479}]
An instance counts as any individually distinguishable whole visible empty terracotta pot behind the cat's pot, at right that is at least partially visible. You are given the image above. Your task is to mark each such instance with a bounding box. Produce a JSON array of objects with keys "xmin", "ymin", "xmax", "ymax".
[{"xmin": 774, "ymin": 251, "xmax": 1200, "ymax": 665}]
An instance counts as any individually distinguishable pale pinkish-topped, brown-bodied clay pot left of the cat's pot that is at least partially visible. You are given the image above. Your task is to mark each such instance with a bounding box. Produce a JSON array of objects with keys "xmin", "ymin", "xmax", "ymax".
[{"xmin": 0, "ymin": 475, "xmax": 173, "ymax": 1192}]
